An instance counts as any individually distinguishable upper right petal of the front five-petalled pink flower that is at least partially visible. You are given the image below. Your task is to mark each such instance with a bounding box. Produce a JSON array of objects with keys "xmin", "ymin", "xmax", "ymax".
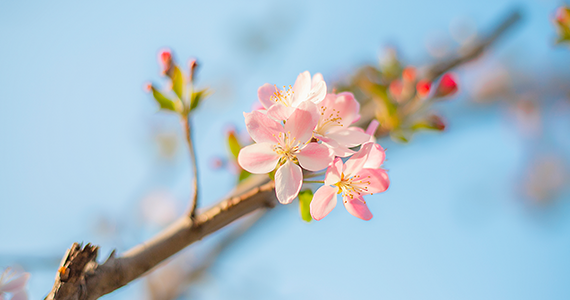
[{"xmin": 285, "ymin": 102, "xmax": 319, "ymax": 143}]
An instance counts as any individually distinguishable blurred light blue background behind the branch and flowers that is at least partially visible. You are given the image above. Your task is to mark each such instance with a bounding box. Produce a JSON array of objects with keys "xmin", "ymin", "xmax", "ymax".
[{"xmin": 0, "ymin": 0, "xmax": 570, "ymax": 299}]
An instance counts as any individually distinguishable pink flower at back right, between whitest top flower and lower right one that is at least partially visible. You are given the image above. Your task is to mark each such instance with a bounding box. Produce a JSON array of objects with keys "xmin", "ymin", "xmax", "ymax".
[{"xmin": 314, "ymin": 92, "xmax": 370, "ymax": 157}]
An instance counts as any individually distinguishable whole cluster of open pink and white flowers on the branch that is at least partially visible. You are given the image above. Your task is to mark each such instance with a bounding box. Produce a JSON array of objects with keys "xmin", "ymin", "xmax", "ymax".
[{"xmin": 238, "ymin": 71, "xmax": 389, "ymax": 220}]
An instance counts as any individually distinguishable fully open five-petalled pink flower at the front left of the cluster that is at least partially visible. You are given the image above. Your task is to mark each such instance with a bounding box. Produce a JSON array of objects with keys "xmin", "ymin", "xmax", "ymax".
[{"xmin": 238, "ymin": 101, "xmax": 333, "ymax": 204}]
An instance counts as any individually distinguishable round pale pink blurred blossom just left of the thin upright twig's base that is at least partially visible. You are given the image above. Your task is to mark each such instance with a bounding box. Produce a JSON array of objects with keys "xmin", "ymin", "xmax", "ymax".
[{"xmin": 141, "ymin": 190, "xmax": 179, "ymax": 226}]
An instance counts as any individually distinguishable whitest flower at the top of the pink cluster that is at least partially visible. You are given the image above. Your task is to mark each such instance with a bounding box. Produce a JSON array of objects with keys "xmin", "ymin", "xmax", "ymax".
[{"xmin": 257, "ymin": 71, "xmax": 327, "ymax": 120}]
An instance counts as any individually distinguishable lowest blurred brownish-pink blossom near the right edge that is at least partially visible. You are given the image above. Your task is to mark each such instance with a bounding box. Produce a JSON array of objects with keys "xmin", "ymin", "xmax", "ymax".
[{"xmin": 523, "ymin": 155, "xmax": 568, "ymax": 204}]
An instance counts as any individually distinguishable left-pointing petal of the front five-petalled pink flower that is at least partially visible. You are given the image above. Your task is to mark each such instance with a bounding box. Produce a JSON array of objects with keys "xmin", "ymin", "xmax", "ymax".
[{"xmin": 238, "ymin": 143, "xmax": 281, "ymax": 174}]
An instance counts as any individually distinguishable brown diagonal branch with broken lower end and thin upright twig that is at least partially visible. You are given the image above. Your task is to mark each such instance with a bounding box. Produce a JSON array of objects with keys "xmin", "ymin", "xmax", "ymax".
[{"xmin": 46, "ymin": 8, "xmax": 520, "ymax": 300}]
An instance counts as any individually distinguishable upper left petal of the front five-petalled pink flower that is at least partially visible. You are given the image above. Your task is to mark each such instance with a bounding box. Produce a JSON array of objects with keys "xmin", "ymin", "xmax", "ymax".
[{"xmin": 243, "ymin": 110, "xmax": 283, "ymax": 143}]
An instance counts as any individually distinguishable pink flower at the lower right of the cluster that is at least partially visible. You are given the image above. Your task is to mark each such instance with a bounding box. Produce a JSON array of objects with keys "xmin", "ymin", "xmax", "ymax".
[{"xmin": 310, "ymin": 143, "xmax": 390, "ymax": 221}]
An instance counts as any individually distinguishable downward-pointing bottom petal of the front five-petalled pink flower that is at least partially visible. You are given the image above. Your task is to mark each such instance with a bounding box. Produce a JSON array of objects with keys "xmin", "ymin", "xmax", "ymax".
[{"xmin": 275, "ymin": 160, "xmax": 303, "ymax": 204}]
